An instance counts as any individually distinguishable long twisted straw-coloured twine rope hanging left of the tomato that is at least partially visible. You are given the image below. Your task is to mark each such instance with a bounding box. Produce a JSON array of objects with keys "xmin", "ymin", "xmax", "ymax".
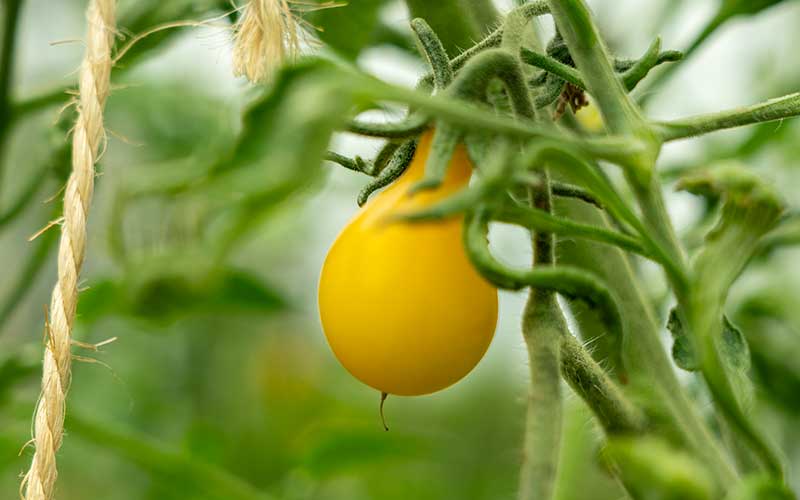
[{"xmin": 21, "ymin": 0, "xmax": 115, "ymax": 500}]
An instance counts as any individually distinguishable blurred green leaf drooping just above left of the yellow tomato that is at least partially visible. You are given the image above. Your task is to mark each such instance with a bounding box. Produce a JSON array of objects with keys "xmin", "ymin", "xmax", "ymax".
[{"xmin": 199, "ymin": 58, "xmax": 353, "ymax": 207}]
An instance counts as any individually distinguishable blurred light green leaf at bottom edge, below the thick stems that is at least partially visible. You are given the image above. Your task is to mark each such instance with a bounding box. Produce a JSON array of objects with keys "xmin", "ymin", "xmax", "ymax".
[{"xmin": 602, "ymin": 437, "xmax": 715, "ymax": 500}]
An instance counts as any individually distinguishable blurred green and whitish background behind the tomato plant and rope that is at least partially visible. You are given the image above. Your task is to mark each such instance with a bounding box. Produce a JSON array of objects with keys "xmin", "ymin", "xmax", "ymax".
[{"xmin": 0, "ymin": 0, "xmax": 800, "ymax": 500}]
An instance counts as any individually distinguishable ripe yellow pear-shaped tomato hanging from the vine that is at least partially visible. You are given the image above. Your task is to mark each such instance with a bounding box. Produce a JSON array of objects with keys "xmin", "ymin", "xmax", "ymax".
[{"xmin": 319, "ymin": 133, "xmax": 497, "ymax": 396}]
